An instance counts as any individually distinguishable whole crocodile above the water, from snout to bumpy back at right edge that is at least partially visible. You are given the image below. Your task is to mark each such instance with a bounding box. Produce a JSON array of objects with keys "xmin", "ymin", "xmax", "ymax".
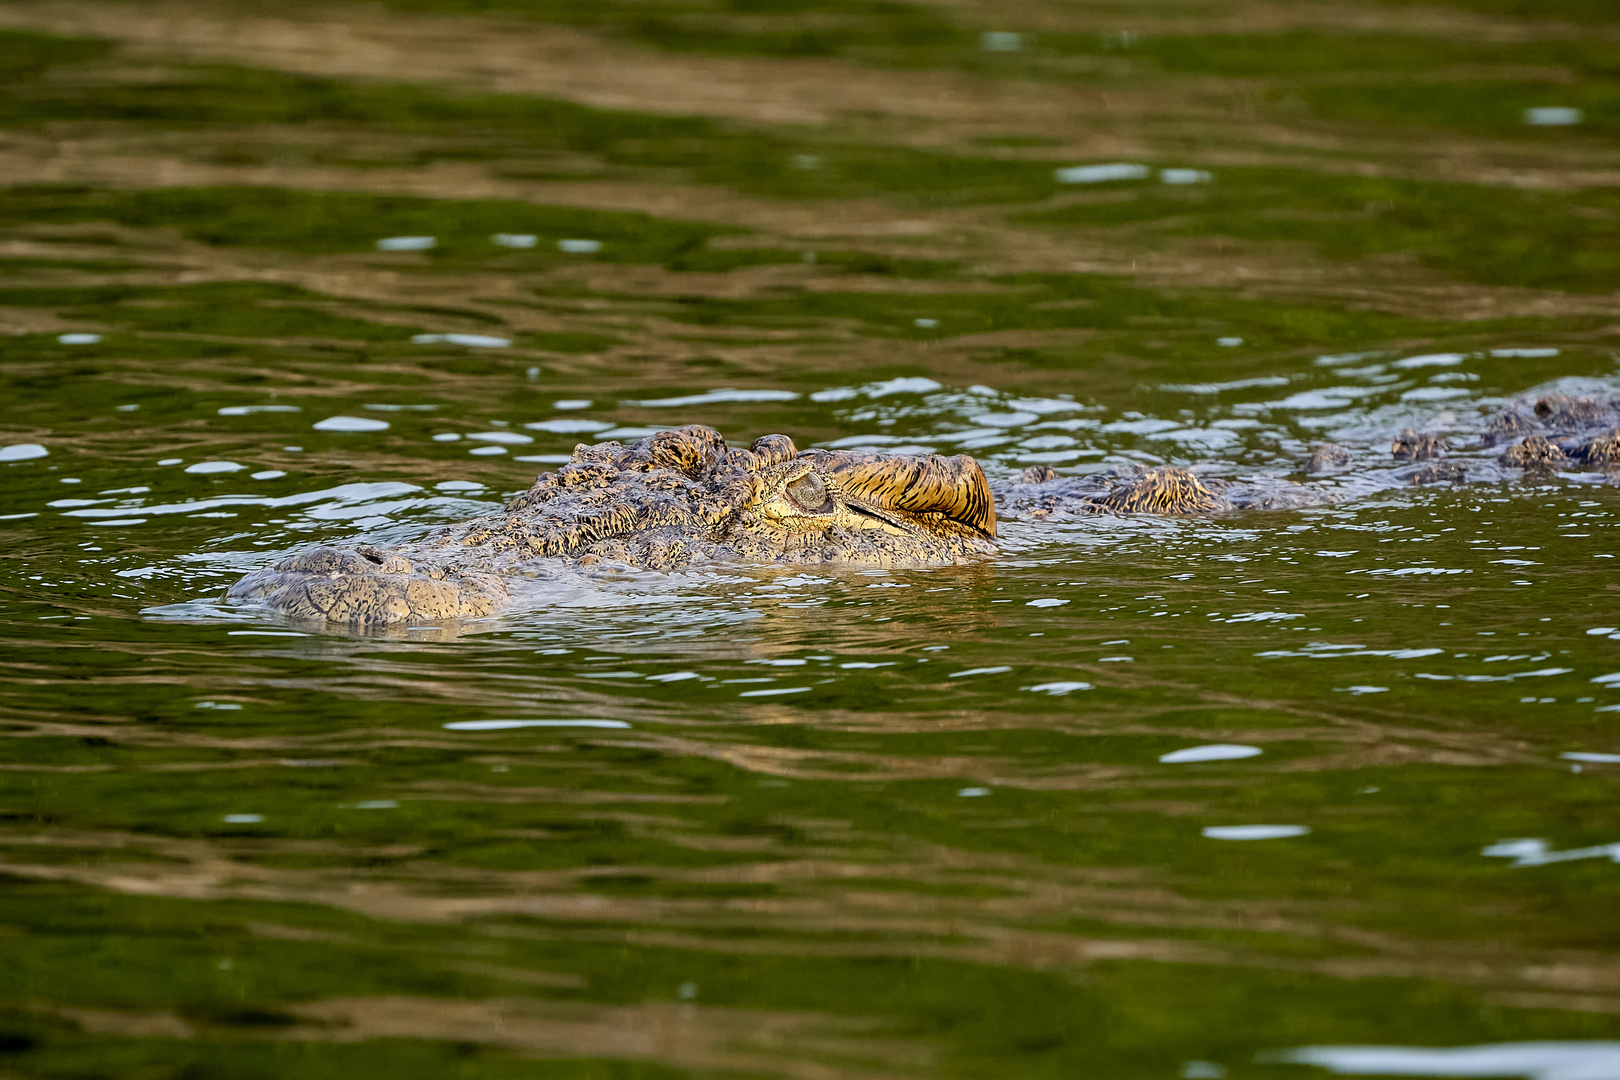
[{"xmin": 230, "ymin": 393, "xmax": 1620, "ymax": 627}]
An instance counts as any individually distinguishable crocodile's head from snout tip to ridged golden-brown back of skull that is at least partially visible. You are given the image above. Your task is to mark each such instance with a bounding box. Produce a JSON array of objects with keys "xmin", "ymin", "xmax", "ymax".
[{"xmin": 230, "ymin": 426, "xmax": 996, "ymax": 627}]
